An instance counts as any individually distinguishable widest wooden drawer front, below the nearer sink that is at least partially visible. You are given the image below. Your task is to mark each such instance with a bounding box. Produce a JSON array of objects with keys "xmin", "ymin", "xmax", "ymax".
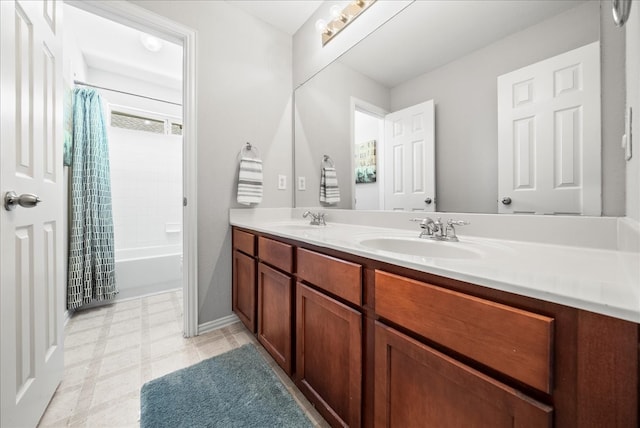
[{"xmin": 375, "ymin": 271, "xmax": 554, "ymax": 393}]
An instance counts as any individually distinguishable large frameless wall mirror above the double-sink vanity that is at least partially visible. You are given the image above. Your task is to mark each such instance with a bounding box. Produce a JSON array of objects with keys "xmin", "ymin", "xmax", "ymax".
[{"xmin": 294, "ymin": 0, "xmax": 625, "ymax": 216}]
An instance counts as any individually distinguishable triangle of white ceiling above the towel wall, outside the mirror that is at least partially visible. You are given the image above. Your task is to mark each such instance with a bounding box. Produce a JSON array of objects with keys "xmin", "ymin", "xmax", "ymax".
[{"xmin": 227, "ymin": 0, "xmax": 324, "ymax": 36}]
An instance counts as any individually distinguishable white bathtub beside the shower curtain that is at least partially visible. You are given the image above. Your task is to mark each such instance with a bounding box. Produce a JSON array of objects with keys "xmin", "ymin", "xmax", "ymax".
[{"xmin": 115, "ymin": 245, "xmax": 182, "ymax": 300}]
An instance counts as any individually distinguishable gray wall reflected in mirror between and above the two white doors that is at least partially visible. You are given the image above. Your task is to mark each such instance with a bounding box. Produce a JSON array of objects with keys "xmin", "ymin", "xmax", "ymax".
[{"xmin": 391, "ymin": 2, "xmax": 624, "ymax": 215}]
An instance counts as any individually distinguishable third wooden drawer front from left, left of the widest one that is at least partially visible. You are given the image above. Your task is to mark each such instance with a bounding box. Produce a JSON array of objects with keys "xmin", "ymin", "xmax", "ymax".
[{"xmin": 297, "ymin": 248, "xmax": 362, "ymax": 305}]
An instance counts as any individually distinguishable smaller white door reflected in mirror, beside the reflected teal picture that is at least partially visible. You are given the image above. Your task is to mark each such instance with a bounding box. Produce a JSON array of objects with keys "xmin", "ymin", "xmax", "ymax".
[{"xmin": 384, "ymin": 100, "xmax": 436, "ymax": 212}]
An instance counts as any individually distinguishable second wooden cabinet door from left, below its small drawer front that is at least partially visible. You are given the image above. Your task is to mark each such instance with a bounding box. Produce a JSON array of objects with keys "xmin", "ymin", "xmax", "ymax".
[{"xmin": 258, "ymin": 263, "xmax": 293, "ymax": 375}]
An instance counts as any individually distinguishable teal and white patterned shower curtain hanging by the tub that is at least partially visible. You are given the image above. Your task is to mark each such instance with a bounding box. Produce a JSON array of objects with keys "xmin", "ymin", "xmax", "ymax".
[{"xmin": 67, "ymin": 88, "xmax": 118, "ymax": 309}]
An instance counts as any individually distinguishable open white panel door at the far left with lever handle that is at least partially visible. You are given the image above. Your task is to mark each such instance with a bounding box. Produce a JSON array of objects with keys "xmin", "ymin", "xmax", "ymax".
[{"xmin": 0, "ymin": 0, "xmax": 65, "ymax": 427}]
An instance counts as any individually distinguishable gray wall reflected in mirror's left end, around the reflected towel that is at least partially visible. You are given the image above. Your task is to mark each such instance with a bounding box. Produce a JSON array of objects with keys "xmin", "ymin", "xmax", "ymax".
[{"xmin": 295, "ymin": 62, "xmax": 389, "ymax": 208}]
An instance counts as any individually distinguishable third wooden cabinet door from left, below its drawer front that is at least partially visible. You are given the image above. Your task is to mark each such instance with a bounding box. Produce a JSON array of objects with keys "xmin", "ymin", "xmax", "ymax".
[{"xmin": 296, "ymin": 282, "xmax": 362, "ymax": 427}]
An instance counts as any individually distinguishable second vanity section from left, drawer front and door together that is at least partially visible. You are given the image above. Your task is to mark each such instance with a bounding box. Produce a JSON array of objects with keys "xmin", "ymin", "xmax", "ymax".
[{"xmin": 257, "ymin": 236, "xmax": 293, "ymax": 376}]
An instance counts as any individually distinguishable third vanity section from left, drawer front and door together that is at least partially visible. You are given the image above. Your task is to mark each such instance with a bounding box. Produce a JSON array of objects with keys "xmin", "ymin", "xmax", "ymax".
[{"xmin": 296, "ymin": 248, "xmax": 362, "ymax": 427}]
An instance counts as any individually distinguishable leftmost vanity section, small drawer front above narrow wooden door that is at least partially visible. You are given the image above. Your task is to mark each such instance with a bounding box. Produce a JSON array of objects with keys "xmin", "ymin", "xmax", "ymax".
[{"xmin": 232, "ymin": 229, "xmax": 256, "ymax": 333}]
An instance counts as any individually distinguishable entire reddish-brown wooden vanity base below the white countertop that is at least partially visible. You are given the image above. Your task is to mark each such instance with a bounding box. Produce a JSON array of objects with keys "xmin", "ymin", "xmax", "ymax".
[{"xmin": 233, "ymin": 228, "xmax": 640, "ymax": 428}]
